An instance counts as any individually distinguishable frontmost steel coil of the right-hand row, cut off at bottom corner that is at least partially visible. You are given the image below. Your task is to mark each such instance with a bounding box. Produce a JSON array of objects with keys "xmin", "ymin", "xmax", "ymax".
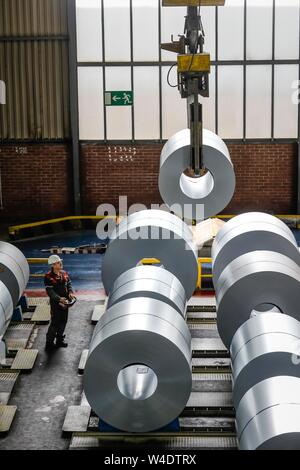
[{"xmin": 236, "ymin": 375, "xmax": 300, "ymax": 450}]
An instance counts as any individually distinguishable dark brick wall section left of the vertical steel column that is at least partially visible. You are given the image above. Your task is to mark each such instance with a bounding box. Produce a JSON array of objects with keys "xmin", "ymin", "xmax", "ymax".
[{"xmin": 0, "ymin": 144, "xmax": 72, "ymax": 223}]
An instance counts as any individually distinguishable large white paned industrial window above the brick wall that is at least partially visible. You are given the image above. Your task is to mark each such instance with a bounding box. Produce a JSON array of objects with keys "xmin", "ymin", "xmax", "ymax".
[{"xmin": 77, "ymin": 0, "xmax": 300, "ymax": 141}]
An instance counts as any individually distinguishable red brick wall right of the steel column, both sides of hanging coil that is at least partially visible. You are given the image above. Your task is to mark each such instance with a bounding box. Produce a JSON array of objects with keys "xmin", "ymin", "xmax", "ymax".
[{"xmin": 81, "ymin": 144, "xmax": 297, "ymax": 214}]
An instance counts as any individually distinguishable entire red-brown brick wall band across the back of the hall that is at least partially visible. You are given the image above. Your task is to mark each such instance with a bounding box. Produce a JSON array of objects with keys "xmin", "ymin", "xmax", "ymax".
[{"xmin": 0, "ymin": 143, "xmax": 297, "ymax": 223}]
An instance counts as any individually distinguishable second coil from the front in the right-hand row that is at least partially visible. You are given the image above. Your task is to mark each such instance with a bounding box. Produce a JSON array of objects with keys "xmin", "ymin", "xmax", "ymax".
[{"xmin": 231, "ymin": 313, "xmax": 300, "ymax": 408}]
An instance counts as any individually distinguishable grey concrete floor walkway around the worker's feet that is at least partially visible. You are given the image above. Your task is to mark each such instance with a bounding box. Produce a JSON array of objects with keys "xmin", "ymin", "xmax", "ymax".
[{"xmin": 0, "ymin": 301, "xmax": 95, "ymax": 450}]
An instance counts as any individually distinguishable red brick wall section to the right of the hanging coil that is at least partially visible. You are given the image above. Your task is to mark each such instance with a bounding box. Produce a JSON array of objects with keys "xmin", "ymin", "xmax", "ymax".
[{"xmin": 224, "ymin": 144, "xmax": 297, "ymax": 214}]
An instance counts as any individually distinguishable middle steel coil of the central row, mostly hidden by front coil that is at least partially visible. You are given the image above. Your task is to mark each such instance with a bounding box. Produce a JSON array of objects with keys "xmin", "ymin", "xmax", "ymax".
[{"xmin": 107, "ymin": 266, "xmax": 187, "ymax": 318}]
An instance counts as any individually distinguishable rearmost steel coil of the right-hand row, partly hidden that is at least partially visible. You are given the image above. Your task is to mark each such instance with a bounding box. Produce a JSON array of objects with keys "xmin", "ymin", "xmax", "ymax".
[{"xmin": 212, "ymin": 212, "xmax": 300, "ymax": 282}]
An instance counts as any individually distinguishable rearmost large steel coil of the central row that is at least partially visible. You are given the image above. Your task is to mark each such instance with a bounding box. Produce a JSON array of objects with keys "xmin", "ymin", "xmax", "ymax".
[{"xmin": 102, "ymin": 210, "xmax": 198, "ymax": 299}]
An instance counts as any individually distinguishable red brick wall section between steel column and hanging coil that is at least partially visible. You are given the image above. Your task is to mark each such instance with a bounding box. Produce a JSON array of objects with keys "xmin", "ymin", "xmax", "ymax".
[{"xmin": 81, "ymin": 144, "xmax": 162, "ymax": 213}]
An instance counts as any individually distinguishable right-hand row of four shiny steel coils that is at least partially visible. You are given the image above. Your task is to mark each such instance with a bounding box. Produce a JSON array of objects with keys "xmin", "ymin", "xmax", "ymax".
[{"xmin": 212, "ymin": 213, "xmax": 300, "ymax": 449}]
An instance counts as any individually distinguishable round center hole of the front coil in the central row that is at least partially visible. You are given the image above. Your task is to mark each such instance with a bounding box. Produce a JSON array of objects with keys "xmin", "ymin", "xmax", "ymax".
[{"xmin": 117, "ymin": 364, "xmax": 158, "ymax": 400}]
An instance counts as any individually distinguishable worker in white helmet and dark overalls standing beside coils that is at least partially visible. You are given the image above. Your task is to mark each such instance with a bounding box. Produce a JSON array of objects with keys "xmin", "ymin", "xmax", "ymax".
[{"xmin": 44, "ymin": 255, "xmax": 75, "ymax": 351}]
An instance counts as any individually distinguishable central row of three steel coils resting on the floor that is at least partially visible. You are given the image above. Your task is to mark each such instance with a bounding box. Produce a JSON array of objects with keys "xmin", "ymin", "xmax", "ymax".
[{"xmin": 84, "ymin": 211, "xmax": 198, "ymax": 432}]
